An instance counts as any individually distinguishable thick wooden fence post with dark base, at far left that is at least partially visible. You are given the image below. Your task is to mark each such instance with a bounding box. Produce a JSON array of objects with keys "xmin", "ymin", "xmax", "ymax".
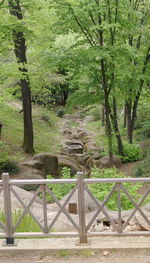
[{"xmin": 2, "ymin": 173, "xmax": 14, "ymax": 245}]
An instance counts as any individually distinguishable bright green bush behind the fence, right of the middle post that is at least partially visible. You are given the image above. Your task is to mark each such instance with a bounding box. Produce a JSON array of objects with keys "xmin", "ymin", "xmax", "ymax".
[{"xmin": 88, "ymin": 168, "xmax": 142, "ymax": 210}]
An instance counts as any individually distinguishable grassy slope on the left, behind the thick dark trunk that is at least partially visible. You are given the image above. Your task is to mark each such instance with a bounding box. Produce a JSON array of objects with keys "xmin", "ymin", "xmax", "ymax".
[{"xmin": 0, "ymin": 99, "xmax": 60, "ymax": 160}]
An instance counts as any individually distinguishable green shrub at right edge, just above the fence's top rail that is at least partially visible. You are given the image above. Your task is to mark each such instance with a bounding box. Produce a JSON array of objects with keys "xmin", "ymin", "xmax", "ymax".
[{"xmin": 134, "ymin": 150, "xmax": 150, "ymax": 177}]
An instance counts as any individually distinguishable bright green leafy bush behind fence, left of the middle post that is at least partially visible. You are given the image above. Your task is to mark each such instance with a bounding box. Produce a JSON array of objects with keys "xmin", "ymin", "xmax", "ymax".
[{"xmin": 46, "ymin": 167, "xmax": 74, "ymax": 202}]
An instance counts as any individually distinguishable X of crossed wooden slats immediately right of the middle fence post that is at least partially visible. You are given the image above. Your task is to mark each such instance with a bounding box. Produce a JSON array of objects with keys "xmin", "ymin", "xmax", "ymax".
[{"xmin": 85, "ymin": 184, "xmax": 117, "ymax": 231}]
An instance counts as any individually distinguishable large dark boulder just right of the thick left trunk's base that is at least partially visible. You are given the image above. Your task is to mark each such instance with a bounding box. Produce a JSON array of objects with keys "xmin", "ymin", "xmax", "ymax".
[{"xmin": 33, "ymin": 153, "xmax": 59, "ymax": 177}]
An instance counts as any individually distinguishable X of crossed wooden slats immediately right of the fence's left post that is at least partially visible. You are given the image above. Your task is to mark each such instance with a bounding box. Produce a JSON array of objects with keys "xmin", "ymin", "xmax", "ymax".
[{"xmin": 10, "ymin": 186, "xmax": 44, "ymax": 232}]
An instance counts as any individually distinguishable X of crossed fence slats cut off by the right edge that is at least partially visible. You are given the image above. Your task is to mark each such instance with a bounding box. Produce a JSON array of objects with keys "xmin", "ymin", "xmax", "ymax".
[{"xmin": 120, "ymin": 184, "xmax": 150, "ymax": 230}]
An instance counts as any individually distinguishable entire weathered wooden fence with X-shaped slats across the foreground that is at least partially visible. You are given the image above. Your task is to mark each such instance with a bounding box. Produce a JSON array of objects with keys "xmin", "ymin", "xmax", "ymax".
[{"xmin": 0, "ymin": 172, "xmax": 150, "ymax": 245}]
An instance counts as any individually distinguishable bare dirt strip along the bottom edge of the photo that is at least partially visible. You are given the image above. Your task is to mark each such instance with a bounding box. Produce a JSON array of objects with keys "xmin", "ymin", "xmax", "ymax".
[{"xmin": 0, "ymin": 250, "xmax": 150, "ymax": 263}]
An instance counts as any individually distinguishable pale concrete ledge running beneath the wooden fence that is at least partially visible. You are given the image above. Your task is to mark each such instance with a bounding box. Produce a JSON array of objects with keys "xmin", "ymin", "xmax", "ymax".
[{"xmin": 0, "ymin": 236, "xmax": 150, "ymax": 255}]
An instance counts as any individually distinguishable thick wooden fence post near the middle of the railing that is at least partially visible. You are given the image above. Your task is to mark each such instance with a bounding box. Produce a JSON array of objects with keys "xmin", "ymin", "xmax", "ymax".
[{"xmin": 77, "ymin": 172, "xmax": 87, "ymax": 244}]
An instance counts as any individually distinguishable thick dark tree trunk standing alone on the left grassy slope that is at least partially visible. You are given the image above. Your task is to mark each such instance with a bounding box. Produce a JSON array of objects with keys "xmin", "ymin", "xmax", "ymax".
[{"xmin": 8, "ymin": 0, "xmax": 34, "ymax": 153}]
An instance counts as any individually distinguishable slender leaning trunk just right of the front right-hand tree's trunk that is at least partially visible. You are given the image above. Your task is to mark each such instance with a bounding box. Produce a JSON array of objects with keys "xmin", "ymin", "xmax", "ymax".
[{"xmin": 110, "ymin": 97, "xmax": 124, "ymax": 156}]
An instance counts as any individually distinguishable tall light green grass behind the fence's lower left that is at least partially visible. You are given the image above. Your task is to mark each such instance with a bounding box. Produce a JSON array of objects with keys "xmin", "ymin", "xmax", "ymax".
[{"xmin": 0, "ymin": 209, "xmax": 41, "ymax": 232}]
